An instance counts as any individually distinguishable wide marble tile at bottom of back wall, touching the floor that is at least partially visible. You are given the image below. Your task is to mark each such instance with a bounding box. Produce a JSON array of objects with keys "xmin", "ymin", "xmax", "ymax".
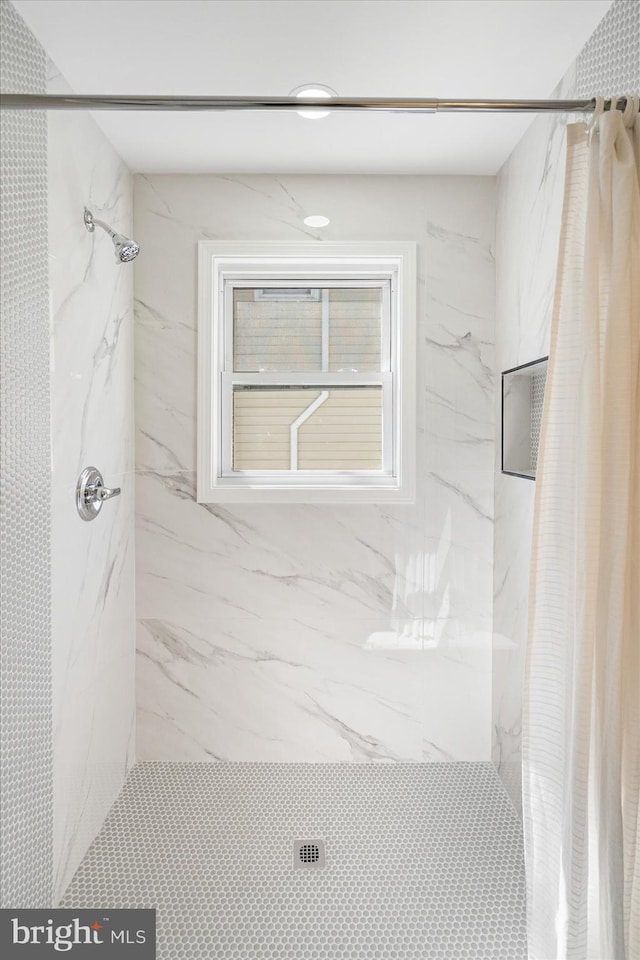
[{"xmin": 138, "ymin": 617, "xmax": 422, "ymax": 762}]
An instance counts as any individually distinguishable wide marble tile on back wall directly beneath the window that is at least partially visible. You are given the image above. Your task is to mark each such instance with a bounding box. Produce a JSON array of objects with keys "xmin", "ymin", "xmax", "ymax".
[{"xmin": 137, "ymin": 471, "xmax": 422, "ymax": 622}]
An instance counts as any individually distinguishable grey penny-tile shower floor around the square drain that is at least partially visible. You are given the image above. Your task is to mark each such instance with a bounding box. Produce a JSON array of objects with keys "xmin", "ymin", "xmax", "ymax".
[{"xmin": 61, "ymin": 763, "xmax": 526, "ymax": 960}]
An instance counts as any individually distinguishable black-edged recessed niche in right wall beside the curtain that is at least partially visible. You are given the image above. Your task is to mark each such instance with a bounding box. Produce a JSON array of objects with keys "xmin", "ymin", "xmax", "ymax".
[{"xmin": 501, "ymin": 357, "xmax": 549, "ymax": 480}]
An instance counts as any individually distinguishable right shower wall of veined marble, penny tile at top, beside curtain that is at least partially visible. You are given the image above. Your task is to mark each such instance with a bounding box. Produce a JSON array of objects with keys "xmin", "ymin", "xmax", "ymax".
[{"xmin": 492, "ymin": 0, "xmax": 640, "ymax": 808}]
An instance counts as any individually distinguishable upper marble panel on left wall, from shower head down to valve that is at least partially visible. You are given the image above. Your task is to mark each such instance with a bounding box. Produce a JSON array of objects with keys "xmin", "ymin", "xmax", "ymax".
[{"xmin": 48, "ymin": 68, "xmax": 134, "ymax": 489}]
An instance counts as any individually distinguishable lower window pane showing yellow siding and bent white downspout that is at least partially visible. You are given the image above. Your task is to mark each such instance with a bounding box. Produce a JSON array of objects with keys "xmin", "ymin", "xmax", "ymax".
[{"xmin": 233, "ymin": 386, "xmax": 382, "ymax": 471}]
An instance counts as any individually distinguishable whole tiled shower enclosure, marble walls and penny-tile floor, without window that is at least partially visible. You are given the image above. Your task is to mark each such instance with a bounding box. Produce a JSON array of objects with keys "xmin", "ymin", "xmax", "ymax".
[{"xmin": 0, "ymin": 0, "xmax": 640, "ymax": 960}]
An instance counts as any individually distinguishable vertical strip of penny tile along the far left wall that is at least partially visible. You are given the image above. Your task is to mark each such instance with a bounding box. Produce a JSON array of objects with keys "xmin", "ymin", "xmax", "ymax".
[{"xmin": 0, "ymin": 0, "xmax": 52, "ymax": 907}]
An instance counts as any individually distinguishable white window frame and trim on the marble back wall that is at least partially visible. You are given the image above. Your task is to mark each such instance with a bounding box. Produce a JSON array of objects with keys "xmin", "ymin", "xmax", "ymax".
[{"xmin": 197, "ymin": 241, "xmax": 416, "ymax": 503}]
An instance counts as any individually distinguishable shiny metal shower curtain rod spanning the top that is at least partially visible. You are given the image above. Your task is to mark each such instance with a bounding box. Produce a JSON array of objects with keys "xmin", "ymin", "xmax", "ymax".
[{"xmin": 0, "ymin": 93, "xmax": 626, "ymax": 113}]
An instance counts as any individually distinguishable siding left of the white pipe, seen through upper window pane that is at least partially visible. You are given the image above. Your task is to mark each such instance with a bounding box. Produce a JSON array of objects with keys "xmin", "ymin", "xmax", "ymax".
[{"xmin": 233, "ymin": 287, "xmax": 322, "ymax": 373}]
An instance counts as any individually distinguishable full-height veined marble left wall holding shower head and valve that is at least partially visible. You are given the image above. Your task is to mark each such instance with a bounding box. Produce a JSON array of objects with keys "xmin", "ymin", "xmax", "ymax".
[{"xmin": 48, "ymin": 64, "xmax": 135, "ymax": 899}]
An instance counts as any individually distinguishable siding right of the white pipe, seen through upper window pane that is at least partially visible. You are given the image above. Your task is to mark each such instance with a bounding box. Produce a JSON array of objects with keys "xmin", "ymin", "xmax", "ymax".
[{"xmin": 327, "ymin": 287, "xmax": 382, "ymax": 371}]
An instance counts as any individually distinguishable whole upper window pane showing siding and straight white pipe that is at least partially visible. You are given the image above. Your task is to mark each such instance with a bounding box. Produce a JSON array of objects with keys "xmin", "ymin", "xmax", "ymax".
[{"xmin": 233, "ymin": 287, "xmax": 383, "ymax": 373}]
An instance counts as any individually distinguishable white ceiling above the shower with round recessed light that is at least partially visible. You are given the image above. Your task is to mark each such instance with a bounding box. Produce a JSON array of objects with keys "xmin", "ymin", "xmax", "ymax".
[{"xmin": 13, "ymin": 0, "xmax": 611, "ymax": 174}]
